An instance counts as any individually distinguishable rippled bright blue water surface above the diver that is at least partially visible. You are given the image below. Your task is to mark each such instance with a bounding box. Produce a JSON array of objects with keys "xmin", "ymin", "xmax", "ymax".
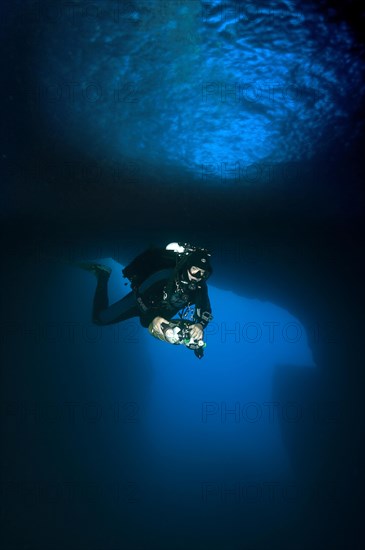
[{"xmin": 37, "ymin": 0, "xmax": 365, "ymax": 186}]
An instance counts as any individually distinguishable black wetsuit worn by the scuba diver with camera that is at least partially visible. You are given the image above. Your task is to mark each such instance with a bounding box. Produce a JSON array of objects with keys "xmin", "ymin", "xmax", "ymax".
[{"xmin": 93, "ymin": 248, "xmax": 211, "ymax": 328}]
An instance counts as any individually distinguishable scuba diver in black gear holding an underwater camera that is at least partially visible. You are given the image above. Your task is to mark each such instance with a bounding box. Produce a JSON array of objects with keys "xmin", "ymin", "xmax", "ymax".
[{"xmin": 78, "ymin": 243, "xmax": 213, "ymax": 359}]
